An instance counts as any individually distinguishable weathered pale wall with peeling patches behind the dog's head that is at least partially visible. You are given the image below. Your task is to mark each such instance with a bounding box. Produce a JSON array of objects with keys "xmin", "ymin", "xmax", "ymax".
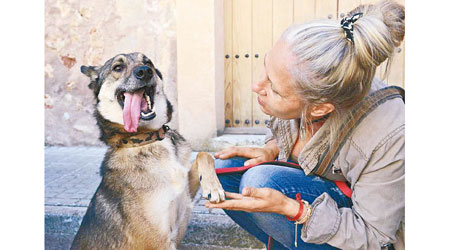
[{"xmin": 45, "ymin": 0, "xmax": 178, "ymax": 146}]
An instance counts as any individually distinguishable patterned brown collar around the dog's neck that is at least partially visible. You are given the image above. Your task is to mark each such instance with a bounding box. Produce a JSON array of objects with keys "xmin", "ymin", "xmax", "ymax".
[{"xmin": 117, "ymin": 125, "xmax": 170, "ymax": 148}]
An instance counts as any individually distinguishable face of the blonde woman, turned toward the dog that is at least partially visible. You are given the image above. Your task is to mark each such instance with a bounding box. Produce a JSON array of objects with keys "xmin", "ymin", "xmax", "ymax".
[{"xmin": 252, "ymin": 40, "xmax": 303, "ymax": 120}]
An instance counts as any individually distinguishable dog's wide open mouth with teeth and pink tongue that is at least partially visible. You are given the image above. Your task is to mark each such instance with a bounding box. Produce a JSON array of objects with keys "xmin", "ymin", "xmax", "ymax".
[{"xmin": 117, "ymin": 87, "xmax": 156, "ymax": 132}]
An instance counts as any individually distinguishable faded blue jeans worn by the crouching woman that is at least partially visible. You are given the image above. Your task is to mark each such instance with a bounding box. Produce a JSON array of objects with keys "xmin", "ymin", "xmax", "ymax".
[{"xmin": 215, "ymin": 157, "xmax": 352, "ymax": 250}]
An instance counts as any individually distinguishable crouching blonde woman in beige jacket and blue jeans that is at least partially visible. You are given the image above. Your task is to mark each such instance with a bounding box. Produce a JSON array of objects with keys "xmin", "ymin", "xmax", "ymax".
[{"xmin": 206, "ymin": 1, "xmax": 405, "ymax": 249}]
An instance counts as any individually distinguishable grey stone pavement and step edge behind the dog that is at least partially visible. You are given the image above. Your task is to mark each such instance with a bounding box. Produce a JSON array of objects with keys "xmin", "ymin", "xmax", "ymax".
[{"xmin": 45, "ymin": 147, "xmax": 264, "ymax": 250}]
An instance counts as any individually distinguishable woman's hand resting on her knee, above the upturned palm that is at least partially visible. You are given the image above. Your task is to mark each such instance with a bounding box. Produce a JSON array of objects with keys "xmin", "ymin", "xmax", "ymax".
[{"xmin": 214, "ymin": 140, "xmax": 279, "ymax": 166}]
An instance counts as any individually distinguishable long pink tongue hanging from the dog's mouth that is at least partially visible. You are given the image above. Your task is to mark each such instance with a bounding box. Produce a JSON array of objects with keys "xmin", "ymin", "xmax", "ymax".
[{"xmin": 123, "ymin": 90, "xmax": 144, "ymax": 132}]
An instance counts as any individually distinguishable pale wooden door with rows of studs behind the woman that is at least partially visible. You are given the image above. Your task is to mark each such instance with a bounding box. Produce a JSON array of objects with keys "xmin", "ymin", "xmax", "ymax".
[{"xmin": 224, "ymin": 0, "xmax": 405, "ymax": 131}]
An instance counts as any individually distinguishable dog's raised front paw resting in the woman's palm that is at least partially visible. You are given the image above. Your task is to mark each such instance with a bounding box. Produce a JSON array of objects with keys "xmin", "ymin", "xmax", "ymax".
[{"xmin": 196, "ymin": 152, "xmax": 225, "ymax": 203}]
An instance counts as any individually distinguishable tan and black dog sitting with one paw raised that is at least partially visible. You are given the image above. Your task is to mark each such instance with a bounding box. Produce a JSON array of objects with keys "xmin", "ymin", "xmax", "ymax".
[{"xmin": 71, "ymin": 52, "xmax": 225, "ymax": 250}]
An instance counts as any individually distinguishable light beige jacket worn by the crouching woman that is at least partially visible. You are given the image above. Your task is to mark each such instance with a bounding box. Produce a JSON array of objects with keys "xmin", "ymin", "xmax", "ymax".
[{"xmin": 266, "ymin": 79, "xmax": 405, "ymax": 250}]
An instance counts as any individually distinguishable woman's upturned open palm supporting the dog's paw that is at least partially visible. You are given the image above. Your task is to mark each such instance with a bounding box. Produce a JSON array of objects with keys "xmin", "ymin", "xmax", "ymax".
[{"xmin": 205, "ymin": 187, "xmax": 300, "ymax": 217}]
